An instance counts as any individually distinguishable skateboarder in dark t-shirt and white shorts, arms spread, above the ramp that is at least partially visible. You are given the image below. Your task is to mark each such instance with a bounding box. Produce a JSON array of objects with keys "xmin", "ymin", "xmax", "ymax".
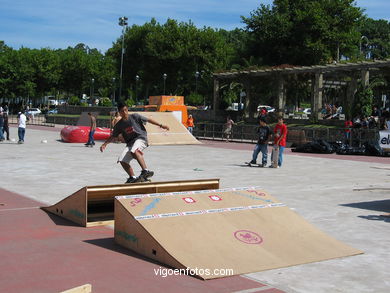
[{"xmin": 100, "ymin": 104, "xmax": 169, "ymax": 183}]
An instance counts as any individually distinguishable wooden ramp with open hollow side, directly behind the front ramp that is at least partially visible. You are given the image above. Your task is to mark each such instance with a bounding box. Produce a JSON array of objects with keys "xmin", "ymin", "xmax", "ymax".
[{"xmin": 42, "ymin": 179, "xmax": 219, "ymax": 227}]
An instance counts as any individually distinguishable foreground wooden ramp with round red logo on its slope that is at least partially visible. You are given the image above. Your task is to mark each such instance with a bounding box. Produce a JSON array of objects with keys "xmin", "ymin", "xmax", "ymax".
[{"xmin": 114, "ymin": 187, "xmax": 362, "ymax": 279}]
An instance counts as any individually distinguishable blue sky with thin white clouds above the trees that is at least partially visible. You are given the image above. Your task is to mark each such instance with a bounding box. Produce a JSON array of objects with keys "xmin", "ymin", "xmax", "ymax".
[{"xmin": 0, "ymin": 0, "xmax": 390, "ymax": 53}]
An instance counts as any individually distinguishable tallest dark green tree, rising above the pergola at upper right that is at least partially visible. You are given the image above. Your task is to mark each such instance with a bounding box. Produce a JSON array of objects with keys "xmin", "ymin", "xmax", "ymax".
[{"xmin": 242, "ymin": 0, "xmax": 363, "ymax": 65}]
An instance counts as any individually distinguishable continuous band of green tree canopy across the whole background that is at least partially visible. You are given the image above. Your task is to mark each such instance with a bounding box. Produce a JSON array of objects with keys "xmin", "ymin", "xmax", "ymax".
[{"xmin": 0, "ymin": 0, "xmax": 390, "ymax": 109}]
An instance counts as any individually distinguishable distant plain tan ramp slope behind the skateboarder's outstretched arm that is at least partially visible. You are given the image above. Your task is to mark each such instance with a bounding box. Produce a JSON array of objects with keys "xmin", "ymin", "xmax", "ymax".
[{"xmin": 130, "ymin": 112, "xmax": 200, "ymax": 145}]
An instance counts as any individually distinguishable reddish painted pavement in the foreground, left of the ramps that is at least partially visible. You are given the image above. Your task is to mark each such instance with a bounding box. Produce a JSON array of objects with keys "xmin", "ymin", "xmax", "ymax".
[{"xmin": 0, "ymin": 188, "xmax": 282, "ymax": 293}]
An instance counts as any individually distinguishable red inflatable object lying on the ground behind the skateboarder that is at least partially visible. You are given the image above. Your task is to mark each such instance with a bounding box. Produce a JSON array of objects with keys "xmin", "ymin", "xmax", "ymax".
[{"xmin": 61, "ymin": 126, "xmax": 111, "ymax": 143}]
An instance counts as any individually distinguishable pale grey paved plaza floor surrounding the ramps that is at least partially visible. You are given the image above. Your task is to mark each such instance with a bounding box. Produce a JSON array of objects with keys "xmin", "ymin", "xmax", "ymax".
[{"xmin": 0, "ymin": 127, "xmax": 390, "ymax": 293}]
